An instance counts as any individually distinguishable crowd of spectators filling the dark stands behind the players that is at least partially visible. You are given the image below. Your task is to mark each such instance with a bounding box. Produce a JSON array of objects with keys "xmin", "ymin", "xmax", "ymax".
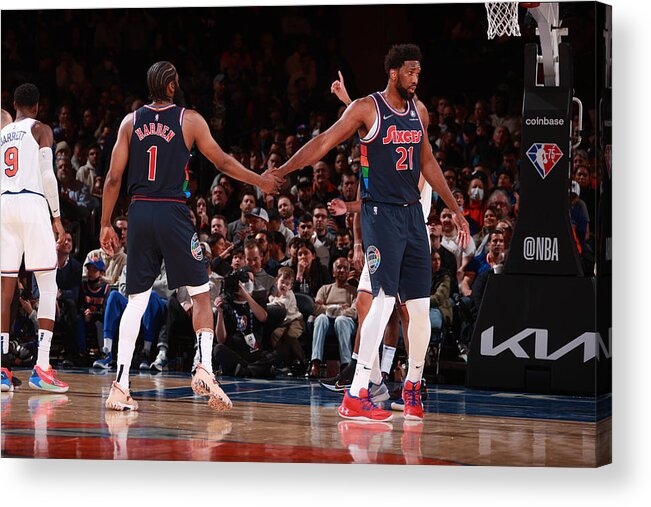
[{"xmin": 2, "ymin": 3, "xmax": 597, "ymax": 376}]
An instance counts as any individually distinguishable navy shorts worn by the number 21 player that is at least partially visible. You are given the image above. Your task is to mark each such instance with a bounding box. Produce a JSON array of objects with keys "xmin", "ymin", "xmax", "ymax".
[{"xmin": 361, "ymin": 201, "xmax": 432, "ymax": 302}]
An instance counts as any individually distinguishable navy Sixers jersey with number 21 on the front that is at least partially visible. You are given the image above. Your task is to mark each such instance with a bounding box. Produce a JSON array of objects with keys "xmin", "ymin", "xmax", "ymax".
[{"xmin": 360, "ymin": 92, "xmax": 426, "ymax": 204}]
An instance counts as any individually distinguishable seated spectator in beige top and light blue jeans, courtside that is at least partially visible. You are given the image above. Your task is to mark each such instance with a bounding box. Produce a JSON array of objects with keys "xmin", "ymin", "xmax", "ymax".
[{"xmin": 306, "ymin": 260, "xmax": 357, "ymax": 378}]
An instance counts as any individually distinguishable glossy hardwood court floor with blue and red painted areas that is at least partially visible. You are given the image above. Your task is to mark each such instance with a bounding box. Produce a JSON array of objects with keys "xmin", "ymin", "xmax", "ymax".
[{"xmin": 2, "ymin": 369, "xmax": 611, "ymax": 467}]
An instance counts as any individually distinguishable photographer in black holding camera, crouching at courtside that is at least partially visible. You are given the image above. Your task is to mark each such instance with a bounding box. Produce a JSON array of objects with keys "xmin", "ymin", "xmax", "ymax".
[{"xmin": 213, "ymin": 266, "xmax": 275, "ymax": 378}]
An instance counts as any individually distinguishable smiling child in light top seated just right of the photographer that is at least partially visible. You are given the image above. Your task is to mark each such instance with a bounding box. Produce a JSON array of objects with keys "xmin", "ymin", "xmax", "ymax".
[{"xmin": 269, "ymin": 267, "xmax": 305, "ymax": 370}]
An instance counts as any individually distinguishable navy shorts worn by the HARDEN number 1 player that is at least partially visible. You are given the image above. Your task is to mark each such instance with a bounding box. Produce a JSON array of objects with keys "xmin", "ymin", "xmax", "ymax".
[{"xmin": 127, "ymin": 201, "xmax": 208, "ymax": 294}]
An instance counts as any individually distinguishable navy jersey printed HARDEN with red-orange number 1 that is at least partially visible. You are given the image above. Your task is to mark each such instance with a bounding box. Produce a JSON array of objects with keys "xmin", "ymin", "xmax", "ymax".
[{"xmin": 128, "ymin": 104, "xmax": 190, "ymax": 201}]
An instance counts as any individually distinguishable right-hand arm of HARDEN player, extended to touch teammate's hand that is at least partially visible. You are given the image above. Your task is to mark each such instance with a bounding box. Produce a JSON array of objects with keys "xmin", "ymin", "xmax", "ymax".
[{"xmin": 184, "ymin": 110, "xmax": 282, "ymax": 194}]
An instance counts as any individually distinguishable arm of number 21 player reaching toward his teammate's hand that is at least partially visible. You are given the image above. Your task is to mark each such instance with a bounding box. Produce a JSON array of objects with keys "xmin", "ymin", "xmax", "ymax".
[{"xmin": 278, "ymin": 97, "xmax": 375, "ymax": 177}]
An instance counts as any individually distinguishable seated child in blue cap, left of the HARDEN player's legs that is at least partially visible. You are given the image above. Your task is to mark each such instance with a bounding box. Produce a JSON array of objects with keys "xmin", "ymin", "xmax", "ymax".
[{"xmin": 72, "ymin": 257, "xmax": 110, "ymax": 366}]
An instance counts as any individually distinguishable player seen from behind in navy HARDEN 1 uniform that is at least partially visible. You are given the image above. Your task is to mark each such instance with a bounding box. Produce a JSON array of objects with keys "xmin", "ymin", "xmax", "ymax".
[{"xmin": 100, "ymin": 61, "xmax": 282, "ymax": 410}]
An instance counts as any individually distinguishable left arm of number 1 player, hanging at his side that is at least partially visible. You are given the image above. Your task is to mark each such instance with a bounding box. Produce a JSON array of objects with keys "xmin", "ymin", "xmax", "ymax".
[{"xmin": 99, "ymin": 113, "xmax": 133, "ymax": 256}]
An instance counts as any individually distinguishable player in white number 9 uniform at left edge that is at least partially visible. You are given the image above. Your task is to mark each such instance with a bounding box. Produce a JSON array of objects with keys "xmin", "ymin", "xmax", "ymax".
[{"xmin": 0, "ymin": 83, "xmax": 68, "ymax": 393}]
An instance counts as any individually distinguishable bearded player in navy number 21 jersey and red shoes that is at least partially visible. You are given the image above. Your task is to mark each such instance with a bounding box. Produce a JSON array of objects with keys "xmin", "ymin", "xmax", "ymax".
[{"xmin": 279, "ymin": 44, "xmax": 470, "ymax": 421}]
